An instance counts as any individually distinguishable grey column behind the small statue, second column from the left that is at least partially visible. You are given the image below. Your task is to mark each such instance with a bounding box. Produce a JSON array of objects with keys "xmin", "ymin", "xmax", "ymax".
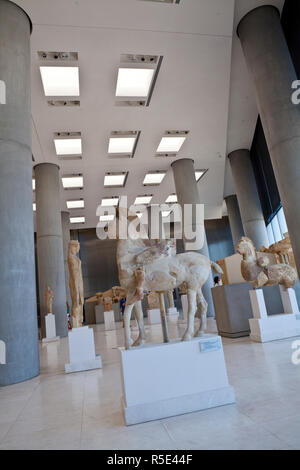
[{"xmin": 35, "ymin": 163, "xmax": 68, "ymax": 336}]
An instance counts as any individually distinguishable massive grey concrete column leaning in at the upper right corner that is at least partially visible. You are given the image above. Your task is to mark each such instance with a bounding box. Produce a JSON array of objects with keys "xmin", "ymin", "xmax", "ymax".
[{"xmin": 238, "ymin": 5, "xmax": 300, "ymax": 272}]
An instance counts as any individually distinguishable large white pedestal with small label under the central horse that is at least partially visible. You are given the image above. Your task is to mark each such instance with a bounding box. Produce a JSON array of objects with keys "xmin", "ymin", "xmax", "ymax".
[{"xmin": 119, "ymin": 335, "xmax": 235, "ymax": 425}]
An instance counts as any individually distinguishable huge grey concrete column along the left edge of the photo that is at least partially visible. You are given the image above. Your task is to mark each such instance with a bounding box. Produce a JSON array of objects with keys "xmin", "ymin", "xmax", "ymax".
[{"xmin": 0, "ymin": 0, "xmax": 39, "ymax": 386}]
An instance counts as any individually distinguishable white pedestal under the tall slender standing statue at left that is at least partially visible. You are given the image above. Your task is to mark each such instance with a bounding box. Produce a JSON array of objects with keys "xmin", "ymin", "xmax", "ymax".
[{"xmin": 65, "ymin": 326, "xmax": 102, "ymax": 374}]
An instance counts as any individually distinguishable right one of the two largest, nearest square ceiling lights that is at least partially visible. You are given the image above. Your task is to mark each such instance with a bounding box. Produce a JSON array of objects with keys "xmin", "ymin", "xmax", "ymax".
[{"xmin": 116, "ymin": 67, "xmax": 154, "ymax": 97}]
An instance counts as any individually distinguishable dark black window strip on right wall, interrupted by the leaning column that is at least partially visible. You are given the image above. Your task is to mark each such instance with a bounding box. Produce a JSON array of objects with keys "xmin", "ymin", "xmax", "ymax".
[{"xmin": 251, "ymin": 0, "xmax": 300, "ymax": 223}]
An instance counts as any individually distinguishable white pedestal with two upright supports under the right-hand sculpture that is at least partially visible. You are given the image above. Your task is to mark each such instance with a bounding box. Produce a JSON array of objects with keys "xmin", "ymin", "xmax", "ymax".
[{"xmin": 249, "ymin": 286, "xmax": 300, "ymax": 343}]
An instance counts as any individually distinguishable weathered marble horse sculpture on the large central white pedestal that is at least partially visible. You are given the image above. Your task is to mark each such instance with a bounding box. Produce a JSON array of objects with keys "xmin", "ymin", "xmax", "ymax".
[{"xmin": 117, "ymin": 217, "xmax": 222, "ymax": 349}]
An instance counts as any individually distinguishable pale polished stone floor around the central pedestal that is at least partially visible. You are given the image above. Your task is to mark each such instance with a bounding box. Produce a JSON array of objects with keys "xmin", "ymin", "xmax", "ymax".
[{"xmin": 0, "ymin": 320, "xmax": 300, "ymax": 450}]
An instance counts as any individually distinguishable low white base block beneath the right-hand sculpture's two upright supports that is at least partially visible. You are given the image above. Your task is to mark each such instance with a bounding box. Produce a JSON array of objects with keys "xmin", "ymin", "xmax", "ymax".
[{"xmin": 249, "ymin": 313, "xmax": 300, "ymax": 343}]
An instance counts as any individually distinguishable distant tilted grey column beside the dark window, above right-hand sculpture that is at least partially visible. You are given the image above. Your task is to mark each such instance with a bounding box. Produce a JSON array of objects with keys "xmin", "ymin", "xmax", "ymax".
[{"xmin": 228, "ymin": 149, "xmax": 269, "ymax": 250}]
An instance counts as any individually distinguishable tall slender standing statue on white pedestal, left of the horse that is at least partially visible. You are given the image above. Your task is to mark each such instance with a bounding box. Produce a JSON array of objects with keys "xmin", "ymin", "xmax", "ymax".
[{"xmin": 68, "ymin": 240, "xmax": 84, "ymax": 328}]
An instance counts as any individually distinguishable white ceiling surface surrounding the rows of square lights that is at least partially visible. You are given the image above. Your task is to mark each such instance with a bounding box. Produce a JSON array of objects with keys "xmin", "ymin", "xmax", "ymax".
[{"xmin": 16, "ymin": 0, "xmax": 283, "ymax": 228}]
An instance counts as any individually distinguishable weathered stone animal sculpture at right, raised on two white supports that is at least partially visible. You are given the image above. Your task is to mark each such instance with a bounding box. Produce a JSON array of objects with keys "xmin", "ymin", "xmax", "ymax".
[{"xmin": 236, "ymin": 237, "xmax": 297, "ymax": 288}]
